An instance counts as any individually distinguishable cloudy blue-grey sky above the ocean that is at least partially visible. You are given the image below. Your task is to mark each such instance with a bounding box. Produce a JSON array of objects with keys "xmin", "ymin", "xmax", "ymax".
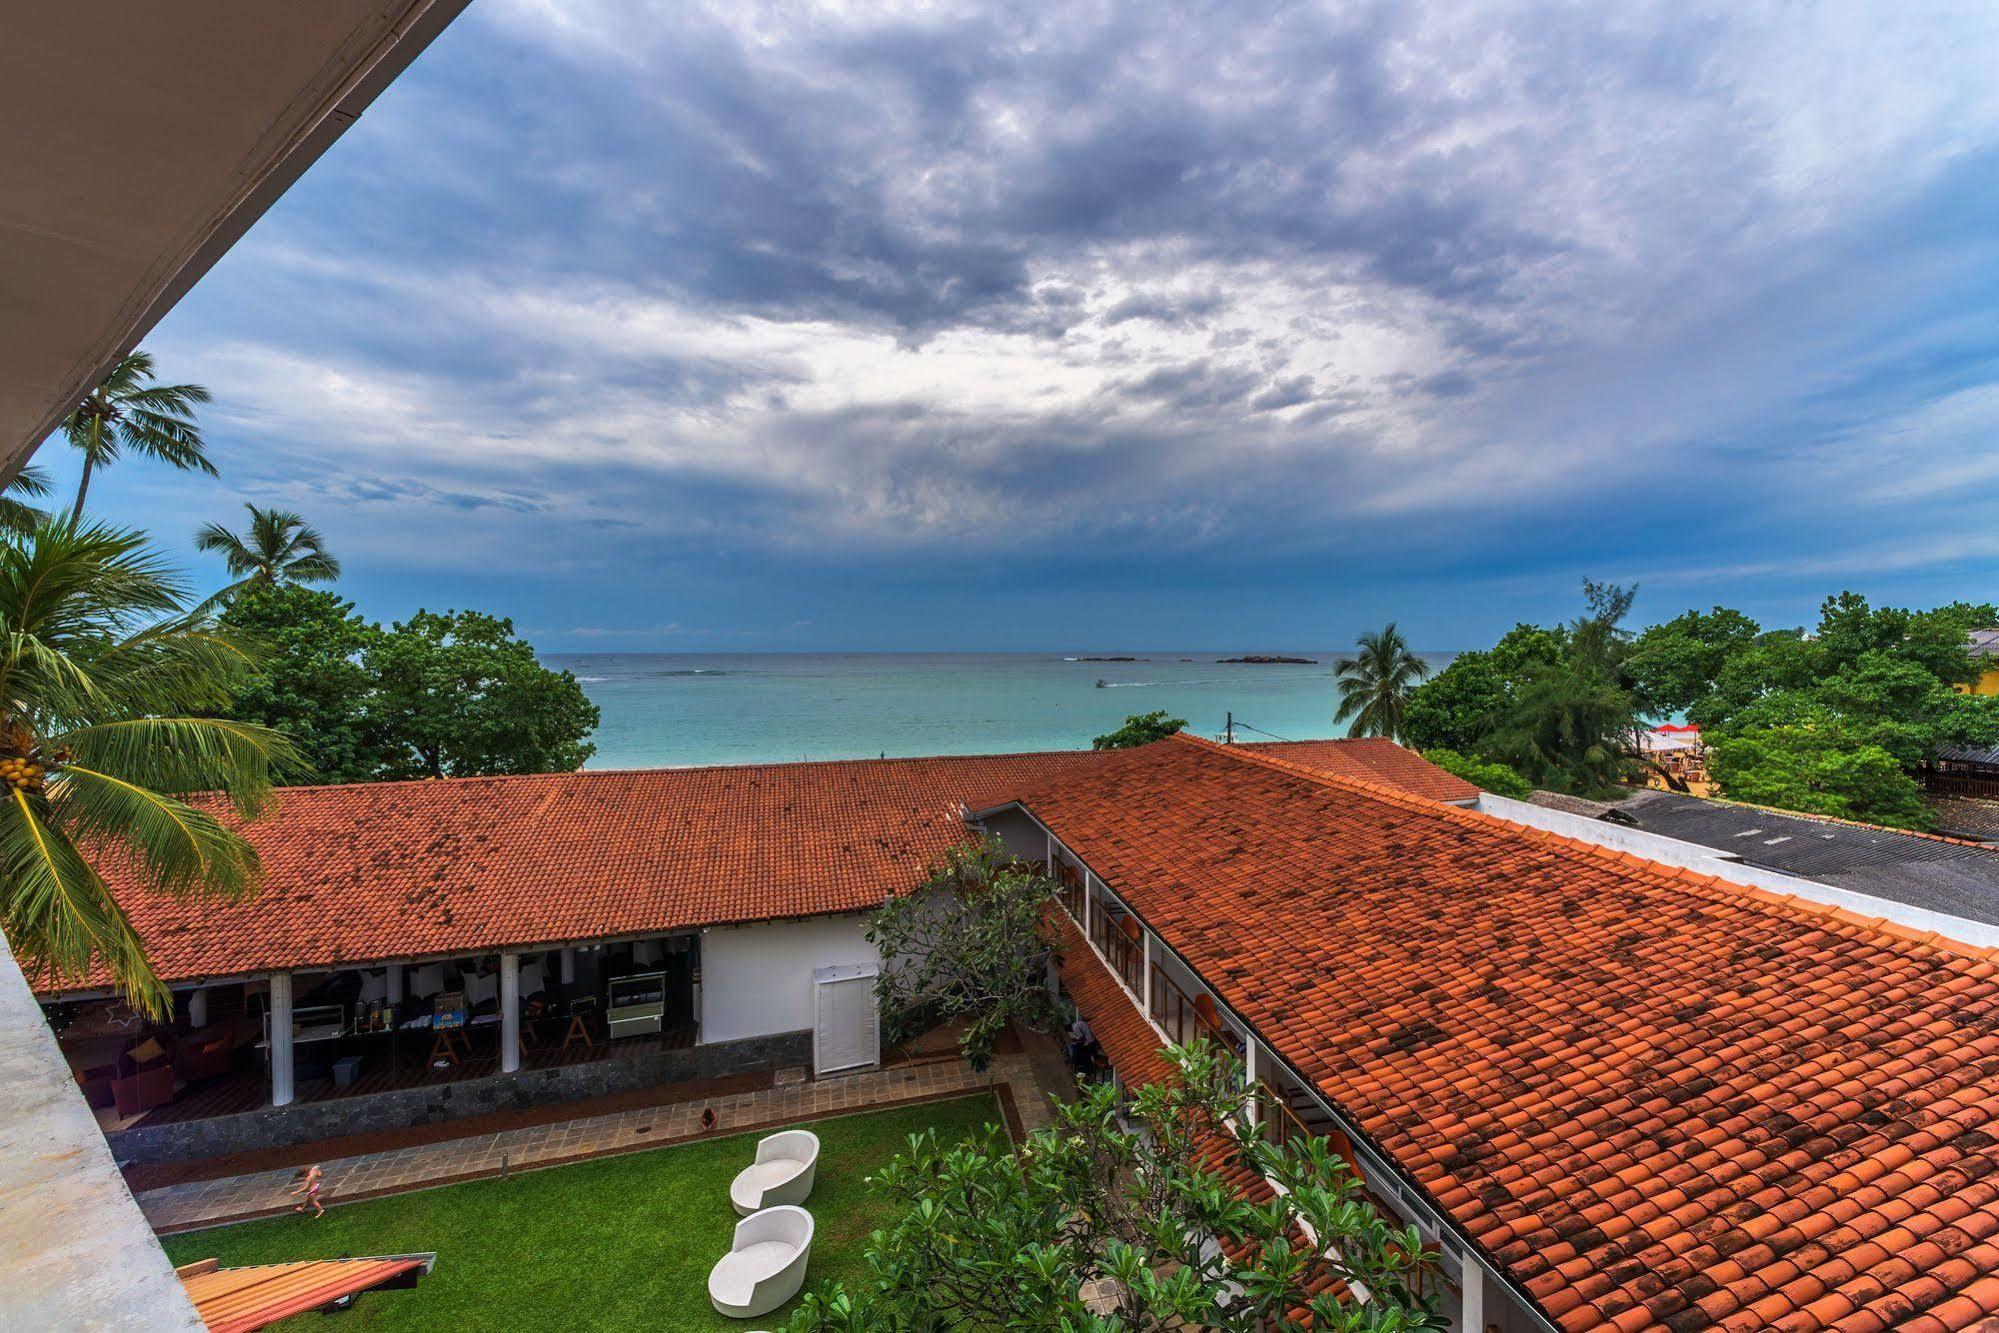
[{"xmin": 44, "ymin": 0, "xmax": 1999, "ymax": 652}]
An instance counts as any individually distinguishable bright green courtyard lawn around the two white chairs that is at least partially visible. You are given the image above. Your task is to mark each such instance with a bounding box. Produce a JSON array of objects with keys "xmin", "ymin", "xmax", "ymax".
[{"xmin": 164, "ymin": 1095, "xmax": 1000, "ymax": 1333}]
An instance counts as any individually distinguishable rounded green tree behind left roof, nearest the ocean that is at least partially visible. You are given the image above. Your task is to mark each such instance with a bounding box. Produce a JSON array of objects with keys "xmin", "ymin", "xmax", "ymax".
[{"xmin": 362, "ymin": 612, "xmax": 598, "ymax": 777}]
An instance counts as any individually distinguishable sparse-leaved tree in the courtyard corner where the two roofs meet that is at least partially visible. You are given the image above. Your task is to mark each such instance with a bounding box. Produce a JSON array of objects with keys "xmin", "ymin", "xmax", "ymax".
[{"xmin": 868, "ymin": 841, "xmax": 1061, "ymax": 1071}]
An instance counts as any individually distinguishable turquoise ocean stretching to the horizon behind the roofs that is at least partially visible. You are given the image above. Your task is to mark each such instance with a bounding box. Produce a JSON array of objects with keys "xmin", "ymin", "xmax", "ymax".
[{"xmin": 544, "ymin": 650, "xmax": 1453, "ymax": 767}]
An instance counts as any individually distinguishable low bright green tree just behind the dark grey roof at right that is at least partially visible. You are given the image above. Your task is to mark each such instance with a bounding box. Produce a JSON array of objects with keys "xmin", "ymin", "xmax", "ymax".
[{"xmin": 1707, "ymin": 725, "xmax": 1931, "ymax": 829}]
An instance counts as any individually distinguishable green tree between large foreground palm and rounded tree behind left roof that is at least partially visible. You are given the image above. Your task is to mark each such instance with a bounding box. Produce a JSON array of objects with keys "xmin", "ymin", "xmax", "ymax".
[{"xmin": 222, "ymin": 584, "xmax": 394, "ymax": 781}]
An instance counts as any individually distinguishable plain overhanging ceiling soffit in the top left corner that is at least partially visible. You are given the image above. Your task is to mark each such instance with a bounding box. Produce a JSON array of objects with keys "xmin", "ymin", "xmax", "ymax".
[{"xmin": 0, "ymin": 0, "xmax": 468, "ymax": 478}]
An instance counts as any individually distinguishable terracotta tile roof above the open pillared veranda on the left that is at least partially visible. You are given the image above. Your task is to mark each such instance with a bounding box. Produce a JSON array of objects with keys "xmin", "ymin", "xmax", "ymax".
[{"xmin": 77, "ymin": 751, "xmax": 1105, "ymax": 981}]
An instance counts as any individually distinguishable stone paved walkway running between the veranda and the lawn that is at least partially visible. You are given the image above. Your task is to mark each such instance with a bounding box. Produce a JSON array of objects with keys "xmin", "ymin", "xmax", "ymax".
[{"xmin": 138, "ymin": 1055, "xmax": 1057, "ymax": 1233}]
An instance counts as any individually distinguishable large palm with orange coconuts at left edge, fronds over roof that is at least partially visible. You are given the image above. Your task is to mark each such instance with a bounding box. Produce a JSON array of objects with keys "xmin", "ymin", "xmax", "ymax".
[{"xmin": 0, "ymin": 518, "xmax": 304, "ymax": 1017}]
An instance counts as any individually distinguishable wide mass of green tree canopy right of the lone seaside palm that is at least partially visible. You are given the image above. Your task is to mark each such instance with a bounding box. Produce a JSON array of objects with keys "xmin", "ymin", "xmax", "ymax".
[{"xmin": 1405, "ymin": 584, "xmax": 1999, "ymax": 827}]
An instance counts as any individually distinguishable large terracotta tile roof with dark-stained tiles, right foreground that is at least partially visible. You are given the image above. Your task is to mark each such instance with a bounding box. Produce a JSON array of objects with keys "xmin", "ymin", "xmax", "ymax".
[{"xmin": 1017, "ymin": 737, "xmax": 1999, "ymax": 1333}]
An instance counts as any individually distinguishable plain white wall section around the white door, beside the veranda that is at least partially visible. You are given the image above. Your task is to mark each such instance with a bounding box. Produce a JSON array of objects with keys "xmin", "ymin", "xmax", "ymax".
[{"xmin": 702, "ymin": 913, "xmax": 880, "ymax": 1043}]
